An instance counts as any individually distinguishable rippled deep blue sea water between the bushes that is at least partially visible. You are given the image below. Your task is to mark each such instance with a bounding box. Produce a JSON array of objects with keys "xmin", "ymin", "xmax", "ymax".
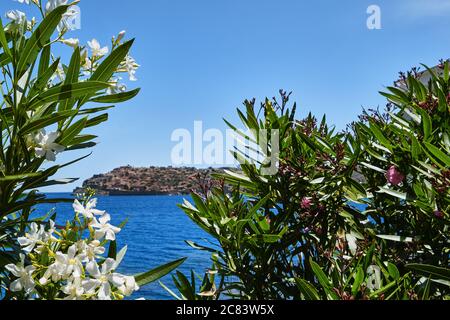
[{"xmin": 36, "ymin": 193, "xmax": 211, "ymax": 299}]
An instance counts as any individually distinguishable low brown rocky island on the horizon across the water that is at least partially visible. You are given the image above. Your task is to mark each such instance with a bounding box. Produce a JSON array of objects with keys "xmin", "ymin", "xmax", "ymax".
[{"xmin": 73, "ymin": 166, "xmax": 223, "ymax": 196}]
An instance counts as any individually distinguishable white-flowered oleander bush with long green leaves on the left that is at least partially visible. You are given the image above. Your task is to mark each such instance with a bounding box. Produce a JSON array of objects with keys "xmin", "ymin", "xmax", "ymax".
[{"xmin": 0, "ymin": 0, "xmax": 184, "ymax": 300}]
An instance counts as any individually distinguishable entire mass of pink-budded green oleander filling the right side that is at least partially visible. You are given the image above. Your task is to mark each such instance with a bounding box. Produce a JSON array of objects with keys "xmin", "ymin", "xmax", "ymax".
[{"xmin": 179, "ymin": 62, "xmax": 450, "ymax": 300}]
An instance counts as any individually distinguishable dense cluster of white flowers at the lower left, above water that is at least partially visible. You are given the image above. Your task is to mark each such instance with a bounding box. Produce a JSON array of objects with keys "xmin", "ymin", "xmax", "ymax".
[{"xmin": 6, "ymin": 199, "xmax": 139, "ymax": 300}]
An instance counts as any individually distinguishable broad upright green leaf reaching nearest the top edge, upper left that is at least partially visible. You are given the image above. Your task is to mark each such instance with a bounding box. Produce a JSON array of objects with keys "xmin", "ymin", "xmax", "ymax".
[{"xmin": 16, "ymin": 5, "xmax": 69, "ymax": 79}]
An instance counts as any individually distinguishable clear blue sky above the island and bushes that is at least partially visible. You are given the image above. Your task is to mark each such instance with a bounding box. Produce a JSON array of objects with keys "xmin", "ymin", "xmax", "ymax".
[{"xmin": 0, "ymin": 0, "xmax": 450, "ymax": 191}]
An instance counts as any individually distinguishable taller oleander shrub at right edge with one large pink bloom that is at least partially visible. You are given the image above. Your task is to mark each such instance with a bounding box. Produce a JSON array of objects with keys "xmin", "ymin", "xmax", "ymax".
[{"xmin": 354, "ymin": 61, "xmax": 450, "ymax": 298}]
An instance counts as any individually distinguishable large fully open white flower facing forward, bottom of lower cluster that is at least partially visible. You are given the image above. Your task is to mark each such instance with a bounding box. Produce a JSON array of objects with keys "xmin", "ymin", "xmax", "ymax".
[{"xmin": 83, "ymin": 258, "xmax": 124, "ymax": 300}]
